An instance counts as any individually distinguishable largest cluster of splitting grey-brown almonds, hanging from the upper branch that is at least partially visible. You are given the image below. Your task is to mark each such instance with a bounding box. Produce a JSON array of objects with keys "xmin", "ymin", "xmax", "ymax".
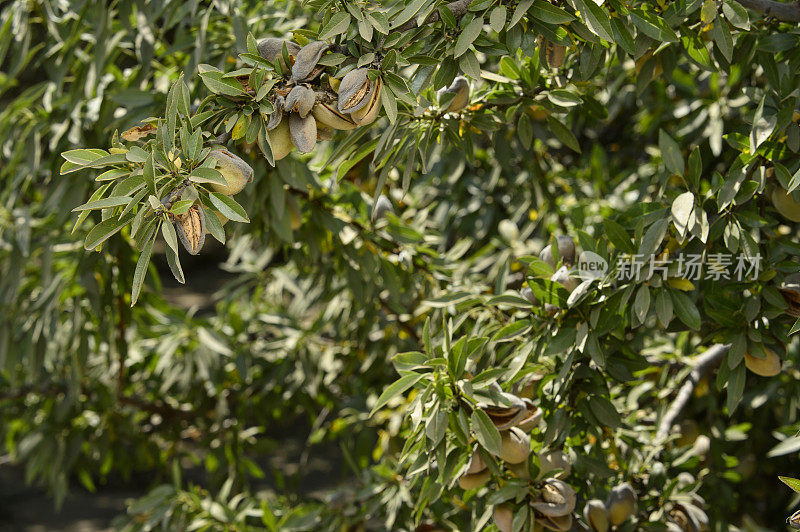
[{"xmin": 258, "ymin": 37, "xmax": 383, "ymax": 161}]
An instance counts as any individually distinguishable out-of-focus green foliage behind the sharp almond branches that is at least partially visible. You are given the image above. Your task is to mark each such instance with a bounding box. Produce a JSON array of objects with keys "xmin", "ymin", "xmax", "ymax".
[{"xmin": 0, "ymin": 0, "xmax": 800, "ymax": 530}]
